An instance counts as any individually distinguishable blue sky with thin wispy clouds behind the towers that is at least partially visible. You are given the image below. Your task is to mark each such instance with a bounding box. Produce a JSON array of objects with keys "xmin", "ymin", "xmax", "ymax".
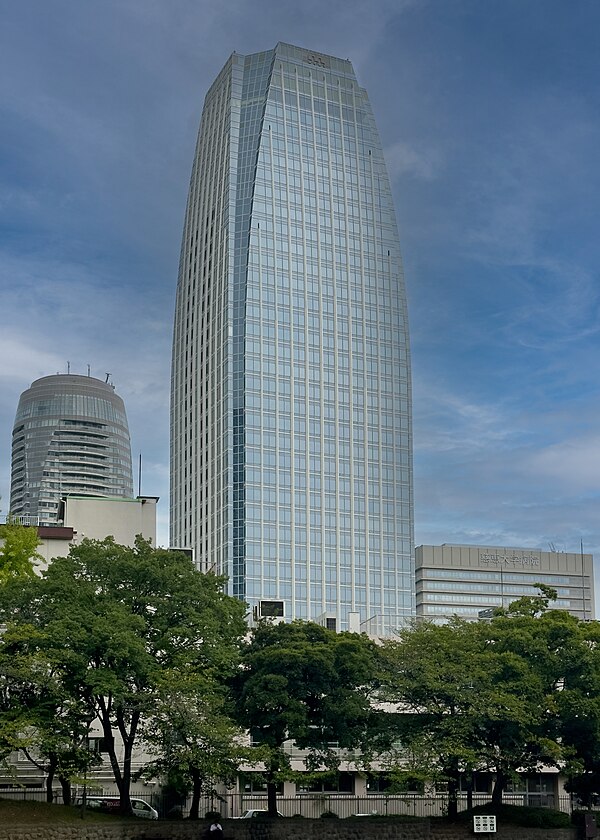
[{"xmin": 0, "ymin": 0, "xmax": 600, "ymax": 580}]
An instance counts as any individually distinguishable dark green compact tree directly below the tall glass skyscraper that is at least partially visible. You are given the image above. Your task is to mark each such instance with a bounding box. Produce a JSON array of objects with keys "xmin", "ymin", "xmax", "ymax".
[{"xmin": 233, "ymin": 621, "xmax": 376, "ymax": 816}]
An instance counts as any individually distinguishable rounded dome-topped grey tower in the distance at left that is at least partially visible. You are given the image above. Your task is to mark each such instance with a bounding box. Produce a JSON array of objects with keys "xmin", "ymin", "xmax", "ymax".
[{"xmin": 10, "ymin": 374, "xmax": 133, "ymax": 525}]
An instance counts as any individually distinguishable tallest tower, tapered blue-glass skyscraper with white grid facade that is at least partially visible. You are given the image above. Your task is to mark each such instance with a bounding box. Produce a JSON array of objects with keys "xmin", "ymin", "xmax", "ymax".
[{"xmin": 171, "ymin": 44, "xmax": 414, "ymax": 633}]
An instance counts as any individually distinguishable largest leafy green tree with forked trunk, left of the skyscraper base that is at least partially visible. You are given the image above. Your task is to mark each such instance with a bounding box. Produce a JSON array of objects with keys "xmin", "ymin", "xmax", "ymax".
[{"xmin": 0, "ymin": 538, "xmax": 246, "ymax": 812}]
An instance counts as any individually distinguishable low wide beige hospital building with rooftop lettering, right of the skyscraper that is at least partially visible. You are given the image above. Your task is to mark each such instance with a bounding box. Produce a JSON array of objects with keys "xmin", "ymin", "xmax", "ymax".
[{"xmin": 415, "ymin": 543, "xmax": 595, "ymax": 623}]
